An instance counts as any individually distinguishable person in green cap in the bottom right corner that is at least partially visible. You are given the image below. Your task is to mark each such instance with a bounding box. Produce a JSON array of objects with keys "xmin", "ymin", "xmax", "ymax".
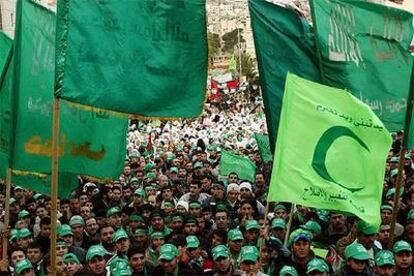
[{"xmin": 392, "ymin": 241, "xmax": 413, "ymax": 275}]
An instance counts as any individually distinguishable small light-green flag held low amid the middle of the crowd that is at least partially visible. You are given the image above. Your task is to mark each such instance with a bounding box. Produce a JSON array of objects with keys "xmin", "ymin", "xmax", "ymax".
[{"xmin": 220, "ymin": 150, "xmax": 256, "ymax": 182}]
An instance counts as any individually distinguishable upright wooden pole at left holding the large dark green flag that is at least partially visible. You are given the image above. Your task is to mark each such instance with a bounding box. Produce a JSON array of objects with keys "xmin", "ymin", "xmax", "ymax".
[{"xmin": 50, "ymin": 97, "xmax": 59, "ymax": 275}]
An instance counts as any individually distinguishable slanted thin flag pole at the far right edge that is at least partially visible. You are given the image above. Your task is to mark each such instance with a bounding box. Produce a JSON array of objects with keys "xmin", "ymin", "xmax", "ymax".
[{"xmin": 388, "ymin": 66, "xmax": 414, "ymax": 248}]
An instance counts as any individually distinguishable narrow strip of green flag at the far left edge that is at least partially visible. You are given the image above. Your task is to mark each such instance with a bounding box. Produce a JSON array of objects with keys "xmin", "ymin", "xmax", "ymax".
[{"xmin": 0, "ymin": 31, "xmax": 13, "ymax": 179}]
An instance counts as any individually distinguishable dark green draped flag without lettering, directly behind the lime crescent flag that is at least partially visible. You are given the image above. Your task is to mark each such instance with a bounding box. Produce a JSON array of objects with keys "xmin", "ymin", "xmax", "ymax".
[{"xmin": 249, "ymin": 0, "xmax": 320, "ymax": 152}]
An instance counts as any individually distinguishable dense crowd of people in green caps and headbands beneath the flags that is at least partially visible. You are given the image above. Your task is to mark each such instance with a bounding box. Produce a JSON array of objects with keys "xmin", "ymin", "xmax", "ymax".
[{"xmin": 0, "ymin": 91, "xmax": 414, "ymax": 276}]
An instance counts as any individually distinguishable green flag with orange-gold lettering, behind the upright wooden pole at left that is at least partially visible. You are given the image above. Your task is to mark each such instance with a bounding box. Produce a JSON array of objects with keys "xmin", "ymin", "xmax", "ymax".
[{"xmin": 10, "ymin": 0, "xmax": 128, "ymax": 196}]
